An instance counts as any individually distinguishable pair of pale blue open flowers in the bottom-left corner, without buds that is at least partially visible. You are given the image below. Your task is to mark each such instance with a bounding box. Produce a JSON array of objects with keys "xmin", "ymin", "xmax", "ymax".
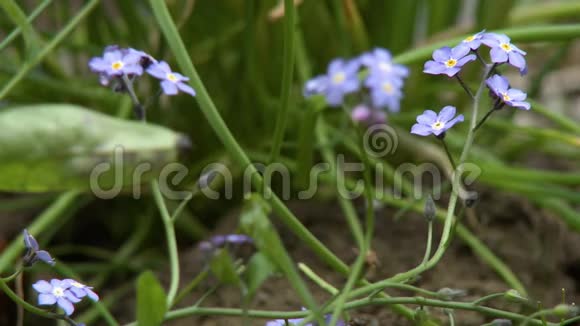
[{"xmin": 32, "ymin": 279, "xmax": 99, "ymax": 316}]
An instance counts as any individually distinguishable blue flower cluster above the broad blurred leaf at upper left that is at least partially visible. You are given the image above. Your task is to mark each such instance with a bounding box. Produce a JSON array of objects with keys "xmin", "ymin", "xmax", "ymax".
[{"xmin": 89, "ymin": 45, "xmax": 195, "ymax": 96}]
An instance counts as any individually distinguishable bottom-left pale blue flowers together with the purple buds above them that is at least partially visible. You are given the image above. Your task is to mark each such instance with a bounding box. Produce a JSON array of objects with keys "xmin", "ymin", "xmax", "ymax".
[{"xmin": 23, "ymin": 229, "xmax": 99, "ymax": 316}]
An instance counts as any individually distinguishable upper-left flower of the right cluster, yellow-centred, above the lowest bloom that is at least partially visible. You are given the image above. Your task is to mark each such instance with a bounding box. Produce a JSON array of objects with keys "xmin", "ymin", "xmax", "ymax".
[{"xmin": 423, "ymin": 46, "xmax": 476, "ymax": 77}]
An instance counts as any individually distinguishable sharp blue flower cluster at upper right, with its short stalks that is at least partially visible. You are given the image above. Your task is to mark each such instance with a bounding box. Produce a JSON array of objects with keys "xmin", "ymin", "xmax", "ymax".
[{"xmin": 411, "ymin": 31, "xmax": 530, "ymax": 138}]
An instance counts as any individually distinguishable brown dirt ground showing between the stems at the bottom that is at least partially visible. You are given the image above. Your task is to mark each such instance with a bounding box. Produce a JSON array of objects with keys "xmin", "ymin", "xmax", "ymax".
[{"xmin": 143, "ymin": 194, "xmax": 580, "ymax": 326}]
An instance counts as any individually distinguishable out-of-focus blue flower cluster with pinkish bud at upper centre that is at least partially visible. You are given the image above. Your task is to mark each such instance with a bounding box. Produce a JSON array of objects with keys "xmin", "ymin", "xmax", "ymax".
[{"xmin": 303, "ymin": 48, "xmax": 409, "ymax": 124}]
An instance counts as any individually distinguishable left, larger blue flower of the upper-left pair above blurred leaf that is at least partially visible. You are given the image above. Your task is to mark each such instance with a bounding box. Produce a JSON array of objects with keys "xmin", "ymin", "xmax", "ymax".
[{"xmin": 89, "ymin": 46, "xmax": 143, "ymax": 77}]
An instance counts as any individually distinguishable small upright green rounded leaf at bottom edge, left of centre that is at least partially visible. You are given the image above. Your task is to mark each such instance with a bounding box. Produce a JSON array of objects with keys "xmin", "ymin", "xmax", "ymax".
[{"xmin": 137, "ymin": 271, "xmax": 167, "ymax": 326}]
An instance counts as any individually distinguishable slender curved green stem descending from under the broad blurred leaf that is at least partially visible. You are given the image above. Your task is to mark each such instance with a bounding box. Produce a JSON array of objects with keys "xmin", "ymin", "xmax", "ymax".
[{"xmin": 151, "ymin": 180, "xmax": 179, "ymax": 308}]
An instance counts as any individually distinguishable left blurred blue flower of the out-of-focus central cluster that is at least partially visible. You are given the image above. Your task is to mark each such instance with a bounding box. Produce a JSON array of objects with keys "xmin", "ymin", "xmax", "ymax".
[{"xmin": 304, "ymin": 59, "xmax": 360, "ymax": 107}]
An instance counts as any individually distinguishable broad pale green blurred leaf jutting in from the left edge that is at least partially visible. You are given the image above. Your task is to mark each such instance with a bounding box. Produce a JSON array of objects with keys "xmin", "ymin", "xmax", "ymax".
[{"xmin": 0, "ymin": 104, "xmax": 183, "ymax": 192}]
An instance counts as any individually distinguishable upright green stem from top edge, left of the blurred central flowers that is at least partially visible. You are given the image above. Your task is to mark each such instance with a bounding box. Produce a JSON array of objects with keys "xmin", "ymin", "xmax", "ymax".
[{"xmin": 270, "ymin": 0, "xmax": 296, "ymax": 163}]
